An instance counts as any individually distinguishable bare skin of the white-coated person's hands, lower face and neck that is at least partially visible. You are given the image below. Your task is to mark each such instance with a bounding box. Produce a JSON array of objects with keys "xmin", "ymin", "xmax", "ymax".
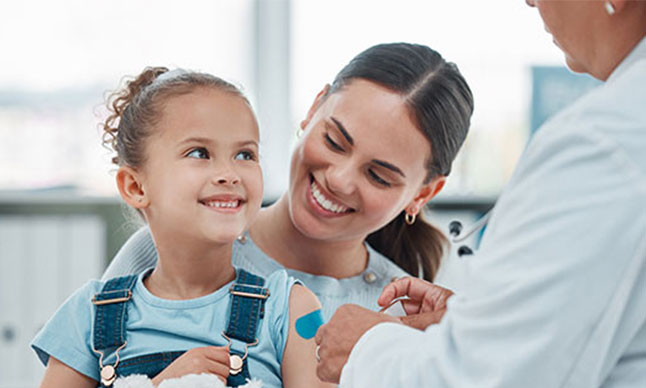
[{"xmin": 316, "ymin": 0, "xmax": 646, "ymax": 383}]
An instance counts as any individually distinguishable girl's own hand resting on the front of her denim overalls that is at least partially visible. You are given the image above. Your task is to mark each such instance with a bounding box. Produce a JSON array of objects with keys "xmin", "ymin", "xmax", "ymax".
[{"xmin": 153, "ymin": 346, "xmax": 229, "ymax": 386}]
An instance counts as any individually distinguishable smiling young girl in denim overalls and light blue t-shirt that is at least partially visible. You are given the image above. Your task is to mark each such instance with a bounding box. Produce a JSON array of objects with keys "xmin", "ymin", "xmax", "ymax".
[{"xmin": 32, "ymin": 68, "xmax": 332, "ymax": 387}]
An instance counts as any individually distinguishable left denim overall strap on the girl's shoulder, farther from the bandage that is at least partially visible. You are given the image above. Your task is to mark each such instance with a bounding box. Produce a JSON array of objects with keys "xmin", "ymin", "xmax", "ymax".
[{"xmin": 92, "ymin": 275, "xmax": 138, "ymax": 351}]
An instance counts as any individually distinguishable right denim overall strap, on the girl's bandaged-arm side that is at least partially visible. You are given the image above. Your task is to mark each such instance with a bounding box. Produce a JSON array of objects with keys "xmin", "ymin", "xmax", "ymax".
[{"xmin": 225, "ymin": 269, "xmax": 269, "ymax": 344}]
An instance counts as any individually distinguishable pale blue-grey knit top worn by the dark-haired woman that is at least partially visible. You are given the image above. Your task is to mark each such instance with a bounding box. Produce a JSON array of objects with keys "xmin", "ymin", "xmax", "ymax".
[{"xmin": 103, "ymin": 227, "xmax": 408, "ymax": 321}]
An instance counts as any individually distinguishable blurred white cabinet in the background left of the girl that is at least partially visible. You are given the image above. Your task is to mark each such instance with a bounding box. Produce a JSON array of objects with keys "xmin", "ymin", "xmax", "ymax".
[{"xmin": 0, "ymin": 215, "xmax": 106, "ymax": 388}]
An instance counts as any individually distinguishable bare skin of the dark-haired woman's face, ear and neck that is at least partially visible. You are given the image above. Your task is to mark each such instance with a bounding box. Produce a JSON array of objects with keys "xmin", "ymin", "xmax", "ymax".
[{"xmin": 250, "ymin": 80, "xmax": 444, "ymax": 278}]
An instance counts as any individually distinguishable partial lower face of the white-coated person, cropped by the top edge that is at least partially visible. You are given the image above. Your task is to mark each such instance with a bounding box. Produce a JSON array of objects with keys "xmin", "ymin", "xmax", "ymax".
[{"xmin": 525, "ymin": 0, "xmax": 607, "ymax": 73}]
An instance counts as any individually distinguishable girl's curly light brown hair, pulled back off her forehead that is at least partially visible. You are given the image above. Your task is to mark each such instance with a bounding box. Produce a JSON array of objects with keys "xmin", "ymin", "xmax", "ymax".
[{"xmin": 102, "ymin": 67, "xmax": 249, "ymax": 167}]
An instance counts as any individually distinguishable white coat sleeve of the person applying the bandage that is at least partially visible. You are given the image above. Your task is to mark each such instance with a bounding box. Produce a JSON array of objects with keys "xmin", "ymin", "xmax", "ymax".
[{"xmin": 340, "ymin": 117, "xmax": 646, "ymax": 388}]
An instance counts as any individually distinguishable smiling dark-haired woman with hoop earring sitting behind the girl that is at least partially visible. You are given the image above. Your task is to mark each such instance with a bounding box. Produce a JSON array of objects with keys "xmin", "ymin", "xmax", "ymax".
[{"xmin": 104, "ymin": 43, "xmax": 473, "ymax": 319}]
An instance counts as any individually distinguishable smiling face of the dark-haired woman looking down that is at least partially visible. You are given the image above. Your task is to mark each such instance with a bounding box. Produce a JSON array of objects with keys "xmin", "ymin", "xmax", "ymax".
[{"xmin": 288, "ymin": 79, "xmax": 444, "ymax": 241}]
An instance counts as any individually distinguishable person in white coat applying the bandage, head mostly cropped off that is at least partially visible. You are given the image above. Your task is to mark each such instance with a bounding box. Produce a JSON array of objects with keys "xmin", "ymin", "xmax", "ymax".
[{"xmin": 316, "ymin": 0, "xmax": 646, "ymax": 388}]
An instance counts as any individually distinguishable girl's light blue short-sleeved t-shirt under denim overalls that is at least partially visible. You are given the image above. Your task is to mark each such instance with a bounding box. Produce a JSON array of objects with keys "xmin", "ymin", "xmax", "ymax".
[{"xmin": 31, "ymin": 270, "xmax": 296, "ymax": 387}]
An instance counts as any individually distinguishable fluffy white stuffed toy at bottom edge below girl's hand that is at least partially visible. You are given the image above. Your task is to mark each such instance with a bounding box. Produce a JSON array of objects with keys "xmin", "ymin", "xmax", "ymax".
[{"xmin": 114, "ymin": 373, "xmax": 262, "ymax": 388}]
